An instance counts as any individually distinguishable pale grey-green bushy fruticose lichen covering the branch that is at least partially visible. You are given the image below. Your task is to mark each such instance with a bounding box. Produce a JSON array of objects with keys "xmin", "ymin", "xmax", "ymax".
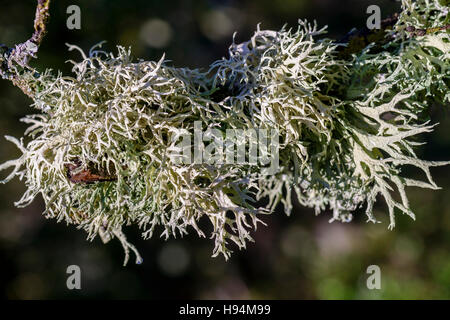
[{"xmin": 0, "ymin": 0, "xmax": 450, "ymax": 263}]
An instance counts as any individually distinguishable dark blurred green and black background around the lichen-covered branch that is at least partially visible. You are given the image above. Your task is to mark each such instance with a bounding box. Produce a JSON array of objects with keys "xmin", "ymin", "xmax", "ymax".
[{"xmin": 0, "ymin": 0, "xmax": 450, "ymax": 299}]
